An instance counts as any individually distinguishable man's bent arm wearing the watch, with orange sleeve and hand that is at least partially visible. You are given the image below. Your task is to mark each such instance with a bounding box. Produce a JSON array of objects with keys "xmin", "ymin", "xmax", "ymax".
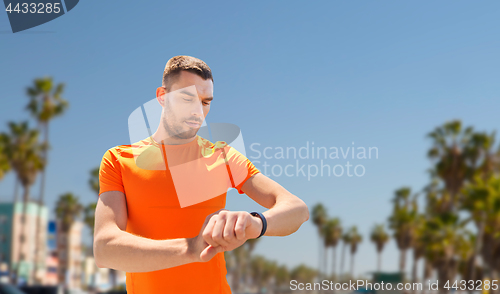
[{"xmin": 203, "ymin": 146, "xmax": 309, "ymax": 251}]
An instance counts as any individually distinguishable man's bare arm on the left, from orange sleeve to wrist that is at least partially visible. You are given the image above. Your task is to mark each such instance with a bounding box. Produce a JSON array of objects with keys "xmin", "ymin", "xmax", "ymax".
[{"xmin": 94, "ymin": 191, "xmax": 217, "ymax": 272}]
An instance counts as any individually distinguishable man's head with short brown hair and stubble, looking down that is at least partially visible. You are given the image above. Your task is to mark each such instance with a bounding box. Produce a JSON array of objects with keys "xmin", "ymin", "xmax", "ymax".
[{"xmin": 156, "ymin": 56, "xmax": 213, "ymax": 140}]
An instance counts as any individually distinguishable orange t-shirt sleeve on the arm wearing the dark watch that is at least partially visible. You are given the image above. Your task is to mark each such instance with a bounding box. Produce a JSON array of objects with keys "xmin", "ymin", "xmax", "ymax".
[{"xmin": 224, "ymin": 146, "xmax": 260, "ymax": 194}]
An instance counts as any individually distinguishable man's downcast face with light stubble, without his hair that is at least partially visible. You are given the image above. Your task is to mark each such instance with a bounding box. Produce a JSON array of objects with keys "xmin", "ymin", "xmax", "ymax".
[{"xmin": 162, "ymin": 71, "xmax": 213, "ymax": 139}]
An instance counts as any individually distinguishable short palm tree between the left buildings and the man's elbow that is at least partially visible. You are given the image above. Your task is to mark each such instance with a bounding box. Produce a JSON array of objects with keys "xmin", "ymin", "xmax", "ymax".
[{"xmin": 55, "ymin": 192, "xmax": 83, "ymax": 284}]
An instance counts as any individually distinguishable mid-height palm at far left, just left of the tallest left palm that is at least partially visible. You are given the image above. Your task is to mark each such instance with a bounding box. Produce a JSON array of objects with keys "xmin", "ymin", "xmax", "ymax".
[{"xmin": 2, "ymin": 122, "xmax": 46, "ymax": 284}]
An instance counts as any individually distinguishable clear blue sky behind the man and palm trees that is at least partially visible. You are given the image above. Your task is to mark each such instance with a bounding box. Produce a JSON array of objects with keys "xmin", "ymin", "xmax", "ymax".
[{"xmin": 0, "ymin": 0, "xmax": 500, "ymax": 280}]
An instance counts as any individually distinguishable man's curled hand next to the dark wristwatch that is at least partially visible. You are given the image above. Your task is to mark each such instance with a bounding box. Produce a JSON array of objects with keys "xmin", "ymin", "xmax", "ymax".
[{"xmin": 188, "ymin": 209, "xmax": 262, "ymax": 261}]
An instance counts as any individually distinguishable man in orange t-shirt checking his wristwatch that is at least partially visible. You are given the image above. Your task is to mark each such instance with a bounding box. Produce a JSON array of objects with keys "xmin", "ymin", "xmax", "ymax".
[{"xmin": 94, "ymin": 56, "xmax": 309, "ymax": 294}]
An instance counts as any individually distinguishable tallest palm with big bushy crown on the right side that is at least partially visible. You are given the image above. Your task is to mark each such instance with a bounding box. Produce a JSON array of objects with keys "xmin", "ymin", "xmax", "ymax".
[{"xmin": 428, "ymin": 120, "xmax": 500, "ymax": 292}]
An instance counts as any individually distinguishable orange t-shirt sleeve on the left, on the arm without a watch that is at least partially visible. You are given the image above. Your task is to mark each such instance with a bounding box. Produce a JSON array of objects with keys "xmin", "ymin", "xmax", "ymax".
[{"xmin": 99, "ymin": 149, "xmax": 125, "ymax": 195}]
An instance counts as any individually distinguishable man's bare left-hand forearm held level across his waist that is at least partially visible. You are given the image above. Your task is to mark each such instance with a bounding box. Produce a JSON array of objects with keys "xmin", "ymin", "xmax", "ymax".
[{"xmin": 94, "ymin": 228, "xmax": 197, "ymax": 272}]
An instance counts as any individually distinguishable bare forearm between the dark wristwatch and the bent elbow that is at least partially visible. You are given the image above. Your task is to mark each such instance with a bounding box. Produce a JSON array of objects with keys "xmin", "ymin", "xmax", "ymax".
[{"xmin": 263, "ymin": 194, "xmax": 309, "ymax": 236}]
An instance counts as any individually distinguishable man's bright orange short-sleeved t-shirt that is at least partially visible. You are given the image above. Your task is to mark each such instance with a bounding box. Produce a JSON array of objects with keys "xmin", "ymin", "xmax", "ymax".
[{"xmin": 99, "ymin": 135, "xmax": 259, "ymax": 294}]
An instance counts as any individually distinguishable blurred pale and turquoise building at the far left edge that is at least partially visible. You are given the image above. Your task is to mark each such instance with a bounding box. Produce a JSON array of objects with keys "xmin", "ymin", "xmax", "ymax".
[{"xmin": 0, "ymin": 201, "xmax": 48, "ymax": 284}]
